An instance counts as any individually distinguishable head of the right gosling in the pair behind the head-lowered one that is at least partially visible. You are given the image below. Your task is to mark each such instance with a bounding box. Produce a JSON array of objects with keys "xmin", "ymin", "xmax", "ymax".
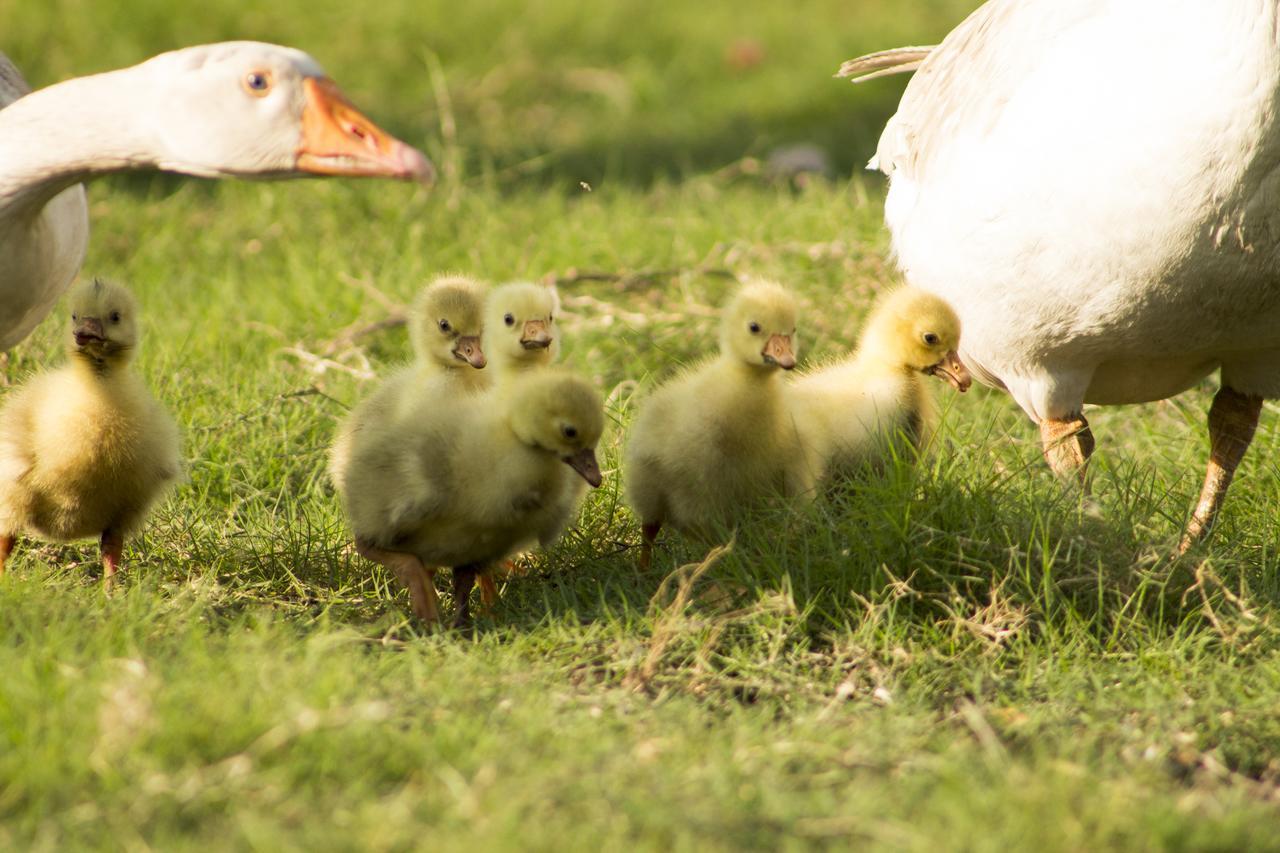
[{"xmin": 485, "ymin": 282, "xmax": 559, "ymax": 370}]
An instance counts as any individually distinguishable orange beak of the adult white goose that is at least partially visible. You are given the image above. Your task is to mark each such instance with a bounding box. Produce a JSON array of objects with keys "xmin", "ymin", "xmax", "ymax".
[{"xmin": 297, "ymin": 77, "xmax": 435, "ymax": 183}]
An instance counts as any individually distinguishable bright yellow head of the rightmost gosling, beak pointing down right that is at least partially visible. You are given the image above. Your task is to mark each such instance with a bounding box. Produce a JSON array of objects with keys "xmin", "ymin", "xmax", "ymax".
[{"xmin": 859, "ymin": 287, "xmax": 973, "ymax": 392}]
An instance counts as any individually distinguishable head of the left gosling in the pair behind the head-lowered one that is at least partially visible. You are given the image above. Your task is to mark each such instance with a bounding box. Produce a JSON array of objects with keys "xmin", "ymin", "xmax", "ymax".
[{"xmin": 408, "ymin": 275, "xmax": 485, "ymax": 369}]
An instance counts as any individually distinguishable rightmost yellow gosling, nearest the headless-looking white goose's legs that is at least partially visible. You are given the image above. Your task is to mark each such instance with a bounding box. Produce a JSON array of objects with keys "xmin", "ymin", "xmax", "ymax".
[{"xmin": 787, "ymin": 287, "xmax": 970, "ymax": 479}]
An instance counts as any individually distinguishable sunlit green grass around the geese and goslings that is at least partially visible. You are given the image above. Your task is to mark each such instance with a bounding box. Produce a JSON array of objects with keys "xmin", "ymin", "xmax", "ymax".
[{"xmin": 0, "ymin": 0, "xmax": 1280, "ymax": 850}]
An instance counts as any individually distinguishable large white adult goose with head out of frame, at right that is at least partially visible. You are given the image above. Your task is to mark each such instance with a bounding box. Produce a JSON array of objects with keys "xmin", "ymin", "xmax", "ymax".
[{"xmin": 841, "ymin": 0, "xmax": 1280, "ymax": 549}]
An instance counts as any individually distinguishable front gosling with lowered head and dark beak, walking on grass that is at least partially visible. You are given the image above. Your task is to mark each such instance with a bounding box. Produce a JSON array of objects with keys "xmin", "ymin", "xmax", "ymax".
[{"xmin": 349, "ymin": 370, "xmax": 604, "ymax": 621}]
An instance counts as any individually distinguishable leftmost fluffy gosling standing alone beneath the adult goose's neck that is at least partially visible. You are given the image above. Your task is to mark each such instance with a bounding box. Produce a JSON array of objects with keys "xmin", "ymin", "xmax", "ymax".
[{"xmin": 0, "ymin": 280, "xmax": 182, "ymax": 580}]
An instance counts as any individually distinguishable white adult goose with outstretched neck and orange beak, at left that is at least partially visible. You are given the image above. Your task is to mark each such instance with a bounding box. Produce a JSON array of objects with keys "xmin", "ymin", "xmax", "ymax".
[{"xmin": 0, "ymin": 41, "xmax": 431, "ymax": 351}]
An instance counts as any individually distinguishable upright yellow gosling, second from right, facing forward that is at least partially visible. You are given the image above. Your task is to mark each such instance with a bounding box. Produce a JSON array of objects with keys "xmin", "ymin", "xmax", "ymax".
[{"xmin": 626, "ymin": 282, "xmax": 812, "ymax": 562}]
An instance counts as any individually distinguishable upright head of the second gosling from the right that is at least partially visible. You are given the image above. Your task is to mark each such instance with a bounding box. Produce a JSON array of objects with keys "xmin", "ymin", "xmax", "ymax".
[{"xmin": 721, "ymin": 282, "xmax": 799, "ymax": 370}]
